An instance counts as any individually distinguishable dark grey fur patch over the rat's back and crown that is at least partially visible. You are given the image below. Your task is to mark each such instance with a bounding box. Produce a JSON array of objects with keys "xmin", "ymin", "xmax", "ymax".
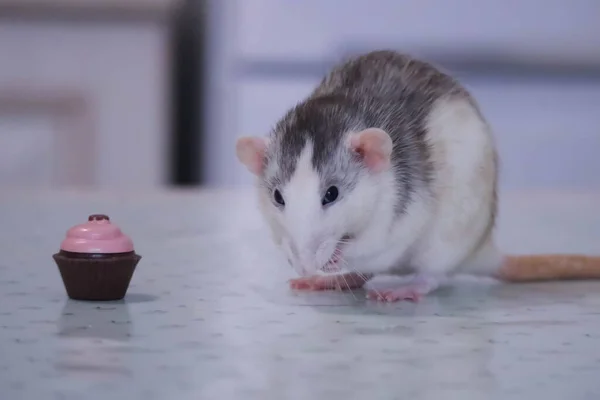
[{"xmin": 263, "ymin": 50, "xmax": 469, "ymax": 212}]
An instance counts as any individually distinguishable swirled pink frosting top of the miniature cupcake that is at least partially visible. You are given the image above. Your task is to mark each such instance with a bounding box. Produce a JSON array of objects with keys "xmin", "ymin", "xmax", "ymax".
[{"xmin": 60, "ymin": 214, "xmax": 133, "ymax": 253}]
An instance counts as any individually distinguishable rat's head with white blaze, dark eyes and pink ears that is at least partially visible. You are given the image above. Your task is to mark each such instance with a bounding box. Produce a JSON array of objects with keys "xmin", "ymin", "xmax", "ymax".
[{"xmin": 236, "ymin": 98, "xmax": 393, "ymax": 275}]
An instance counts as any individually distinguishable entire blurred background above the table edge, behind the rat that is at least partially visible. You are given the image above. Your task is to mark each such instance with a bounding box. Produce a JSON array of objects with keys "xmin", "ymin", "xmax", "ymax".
[{"xmin": 0, "ymin": 0, "xmax": 600, "ymax": 195}]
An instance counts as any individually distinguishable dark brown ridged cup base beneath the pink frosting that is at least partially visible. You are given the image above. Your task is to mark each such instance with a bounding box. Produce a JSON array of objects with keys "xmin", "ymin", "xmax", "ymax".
[{"xmin": 52, "ymin": 250, "xmax": 142, "ymax": 301}]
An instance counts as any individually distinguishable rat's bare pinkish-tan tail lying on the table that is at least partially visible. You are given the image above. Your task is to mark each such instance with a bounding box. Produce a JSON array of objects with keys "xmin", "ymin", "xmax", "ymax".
[{"xmin": 494, "ymin": 254, "xmax": 600, "ymax": 282}]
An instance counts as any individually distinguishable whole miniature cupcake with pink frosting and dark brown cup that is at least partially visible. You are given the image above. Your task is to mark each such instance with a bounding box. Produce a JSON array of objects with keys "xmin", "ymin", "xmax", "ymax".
[{"xmin": 52, "ymin": 214, "xmax": 142, "ymax": 301}]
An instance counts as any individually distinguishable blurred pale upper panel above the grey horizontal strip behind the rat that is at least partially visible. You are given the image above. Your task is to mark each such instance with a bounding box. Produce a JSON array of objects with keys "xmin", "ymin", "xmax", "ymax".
[{"xmin": 238, "ymin": 0, "xmax": 600, "ymax": 62}]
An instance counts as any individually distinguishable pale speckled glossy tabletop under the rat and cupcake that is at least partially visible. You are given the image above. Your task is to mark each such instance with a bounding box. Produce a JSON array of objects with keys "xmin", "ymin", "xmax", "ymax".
[{"xmin": 0, "ymin": 190, "xmax": 600, "ymax": 400}]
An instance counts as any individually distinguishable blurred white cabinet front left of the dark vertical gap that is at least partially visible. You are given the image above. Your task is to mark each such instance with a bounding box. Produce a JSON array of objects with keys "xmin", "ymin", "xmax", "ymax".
[{"xmin": 0, "ymin": 11, "xmax": 170, "ymax": 188}]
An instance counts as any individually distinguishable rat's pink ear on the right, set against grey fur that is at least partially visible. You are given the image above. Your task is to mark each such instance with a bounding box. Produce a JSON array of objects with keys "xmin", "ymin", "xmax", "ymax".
[{"xmin": 350, "ymin": 128, "xmax": 393, "ymax": 172}]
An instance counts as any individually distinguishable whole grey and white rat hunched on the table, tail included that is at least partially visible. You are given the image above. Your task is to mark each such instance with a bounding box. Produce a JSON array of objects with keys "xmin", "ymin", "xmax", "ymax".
[{"xmin": 236, "ymin": 50, "xmax": 600, "ymax": 302}]
